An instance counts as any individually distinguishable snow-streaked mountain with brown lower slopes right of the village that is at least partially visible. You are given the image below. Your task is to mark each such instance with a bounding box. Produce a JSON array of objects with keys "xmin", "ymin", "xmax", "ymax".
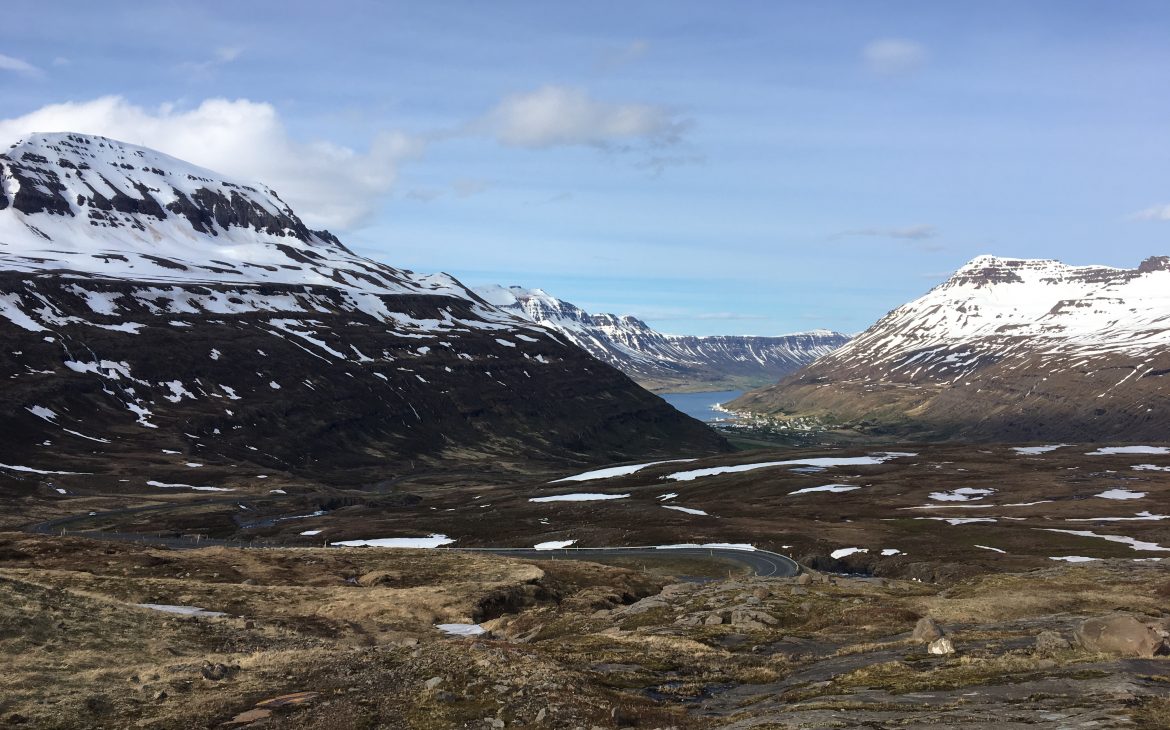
[{"xmin": 731, "ymin": 256, "xmax": 1170, "ymax": 440}]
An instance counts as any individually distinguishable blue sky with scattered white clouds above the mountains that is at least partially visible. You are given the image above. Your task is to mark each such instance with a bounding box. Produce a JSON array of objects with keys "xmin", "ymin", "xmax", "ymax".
[{"xmin": 0, "ymin": 0, "xmax": 1170, "ymax": 335}]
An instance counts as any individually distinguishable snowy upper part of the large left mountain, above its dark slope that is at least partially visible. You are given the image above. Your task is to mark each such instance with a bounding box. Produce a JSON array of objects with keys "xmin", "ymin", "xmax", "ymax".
[{"xmin": 0, "ymin": 132, "xmax": 470, "ymax": 297}]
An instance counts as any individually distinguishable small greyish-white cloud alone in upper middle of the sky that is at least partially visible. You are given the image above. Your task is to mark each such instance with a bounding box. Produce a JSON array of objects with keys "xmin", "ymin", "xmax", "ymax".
[{"xmin": 472, "ymin": 85, "xmax": 688, "ymax": 152}]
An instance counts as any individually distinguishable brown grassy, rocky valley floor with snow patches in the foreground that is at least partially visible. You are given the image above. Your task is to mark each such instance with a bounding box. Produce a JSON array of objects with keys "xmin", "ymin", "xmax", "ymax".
[{"xmin": 0, "ymin": 445, "xmax": 1170, "ymax": 730}]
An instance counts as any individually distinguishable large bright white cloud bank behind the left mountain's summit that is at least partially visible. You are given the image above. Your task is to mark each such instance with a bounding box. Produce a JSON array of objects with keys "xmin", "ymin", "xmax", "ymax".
[{"xmin": 0, "ymin": 96, "xmax": 422, "ymax": 230}]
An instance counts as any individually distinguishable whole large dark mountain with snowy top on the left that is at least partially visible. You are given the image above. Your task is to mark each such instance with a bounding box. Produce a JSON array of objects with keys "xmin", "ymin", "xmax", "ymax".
[{"xmin": 0, "ymin": 133, "xmax": 722, "ymax": 491}]
